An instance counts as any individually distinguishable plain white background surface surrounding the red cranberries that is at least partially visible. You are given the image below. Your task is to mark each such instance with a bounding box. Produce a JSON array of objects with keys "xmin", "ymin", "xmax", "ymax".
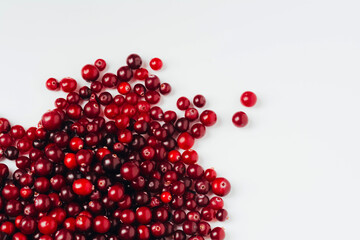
[{"xmin": 0, "ymin": 0, "xmax": 360, "ymax": 240}]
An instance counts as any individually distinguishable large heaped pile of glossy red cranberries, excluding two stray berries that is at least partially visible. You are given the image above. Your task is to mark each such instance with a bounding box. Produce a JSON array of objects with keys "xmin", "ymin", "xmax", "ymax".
[{"xmin": 0, "ymin": 54, "xmax": 231, "ymax": 240}]
